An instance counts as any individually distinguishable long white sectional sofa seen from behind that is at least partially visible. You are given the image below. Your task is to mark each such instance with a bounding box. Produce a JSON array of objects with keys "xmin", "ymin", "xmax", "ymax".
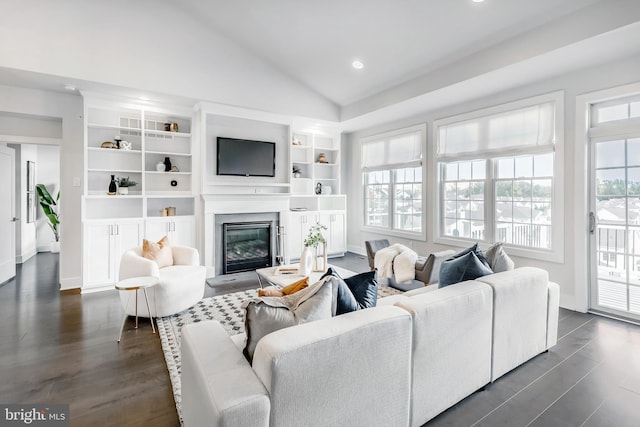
[{"xmin": 182, "ymin": 267, "xmax": 559, "ymax": 427}]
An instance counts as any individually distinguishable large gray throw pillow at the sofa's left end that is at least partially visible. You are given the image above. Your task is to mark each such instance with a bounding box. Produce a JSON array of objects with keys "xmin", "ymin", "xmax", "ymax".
[{"xmin": 242, "ymin": 281, "xmax": 333, "ymax": 363}]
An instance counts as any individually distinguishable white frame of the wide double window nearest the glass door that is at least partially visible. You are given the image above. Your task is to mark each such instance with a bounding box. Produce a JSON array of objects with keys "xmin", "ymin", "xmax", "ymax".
[{"xmin": 429, "ymin": 91, "xmax": 565, "ymax": 263}]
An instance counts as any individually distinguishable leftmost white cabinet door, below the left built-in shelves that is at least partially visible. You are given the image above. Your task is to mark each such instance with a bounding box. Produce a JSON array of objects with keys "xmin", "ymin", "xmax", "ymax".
[{"xmin": 83, "ymin": 221, "xmax": 116, "ymax": 288}]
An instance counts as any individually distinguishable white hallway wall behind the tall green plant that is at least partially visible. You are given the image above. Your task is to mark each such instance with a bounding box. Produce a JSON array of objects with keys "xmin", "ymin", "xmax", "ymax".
[{"xmin": 36, "ymin": 145, "xmax": 62, "ymax": 252}]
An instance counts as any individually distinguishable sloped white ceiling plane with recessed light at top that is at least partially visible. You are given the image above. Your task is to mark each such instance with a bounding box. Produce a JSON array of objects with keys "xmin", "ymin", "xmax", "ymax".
[{"xmin": 174, "ymin": 0, "xmax": 597, "ymax": 106}]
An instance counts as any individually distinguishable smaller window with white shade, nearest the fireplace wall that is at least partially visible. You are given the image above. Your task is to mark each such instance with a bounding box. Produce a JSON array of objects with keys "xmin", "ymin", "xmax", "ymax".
[{"xmin": 361, "ymin": 125, "xmax": 426, "ymax": 236}]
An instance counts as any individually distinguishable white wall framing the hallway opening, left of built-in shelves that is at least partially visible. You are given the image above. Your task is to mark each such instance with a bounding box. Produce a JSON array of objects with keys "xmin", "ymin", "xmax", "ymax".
[{"xmin": 0, "ymin": 86, "xmax": 84, "ymax": 289}]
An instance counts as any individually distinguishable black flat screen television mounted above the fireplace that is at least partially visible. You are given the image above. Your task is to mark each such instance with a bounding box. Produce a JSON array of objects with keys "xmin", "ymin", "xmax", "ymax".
[{"xmin": 216, "ymin": 136, "xmax": 276, "ymax": 176}]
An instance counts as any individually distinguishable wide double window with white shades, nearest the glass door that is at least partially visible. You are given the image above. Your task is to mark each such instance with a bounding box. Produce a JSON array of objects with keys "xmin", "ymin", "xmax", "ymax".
[{"xmin": 435, "ymin": 93, "xmax": 563, "ymax": 259}]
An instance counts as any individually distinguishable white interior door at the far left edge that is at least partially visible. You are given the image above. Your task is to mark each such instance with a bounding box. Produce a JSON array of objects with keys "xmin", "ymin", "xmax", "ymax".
[{"xmin": 0, "ymin": 146, "xmax": 18, "ymax": 283}]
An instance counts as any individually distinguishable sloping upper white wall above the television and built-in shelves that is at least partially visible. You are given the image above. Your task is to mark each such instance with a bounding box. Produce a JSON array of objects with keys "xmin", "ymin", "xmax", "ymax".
[{"xmin": 0, "ymin": 0, "xmax": 339, "ymax": 120}]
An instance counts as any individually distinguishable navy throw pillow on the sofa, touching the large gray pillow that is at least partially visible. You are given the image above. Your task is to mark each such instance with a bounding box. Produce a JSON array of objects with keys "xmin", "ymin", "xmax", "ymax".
[{"xmin": 322, "ymin": 267, "xmax": 378, "ymax": 315}]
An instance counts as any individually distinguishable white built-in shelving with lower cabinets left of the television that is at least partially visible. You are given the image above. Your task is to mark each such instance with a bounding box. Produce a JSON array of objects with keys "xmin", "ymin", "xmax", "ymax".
[{"xmin": 82, "ymin": 95, "xmax": 196, "ymax": 290}]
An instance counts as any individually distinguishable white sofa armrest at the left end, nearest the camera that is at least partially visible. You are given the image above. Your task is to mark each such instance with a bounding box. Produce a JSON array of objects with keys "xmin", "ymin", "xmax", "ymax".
[{"xmin": 181, "ymin": 321, "xmax": 270, "ymax": 427}]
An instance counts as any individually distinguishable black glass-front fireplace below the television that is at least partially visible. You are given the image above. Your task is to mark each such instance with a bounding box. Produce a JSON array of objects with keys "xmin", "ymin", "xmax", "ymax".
[{"xmin": 222, "ymin": 221, "xmax": 273, "ymax": 274}]
